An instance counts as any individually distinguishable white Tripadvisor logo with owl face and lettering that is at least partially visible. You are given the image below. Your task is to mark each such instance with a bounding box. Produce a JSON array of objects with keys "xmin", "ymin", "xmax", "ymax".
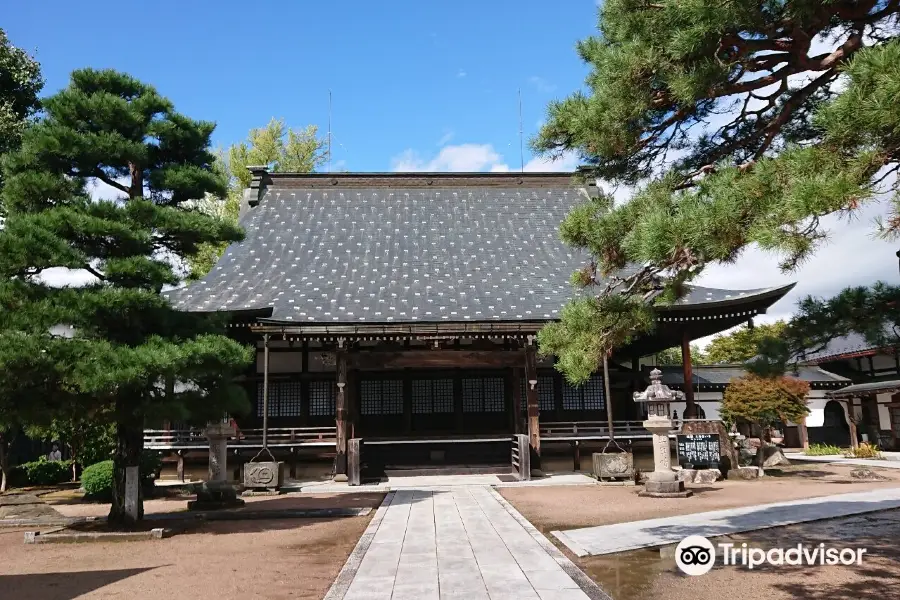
[{"xmin": 675, "ymin": 535, "xmax": 867, "ymax": 575}]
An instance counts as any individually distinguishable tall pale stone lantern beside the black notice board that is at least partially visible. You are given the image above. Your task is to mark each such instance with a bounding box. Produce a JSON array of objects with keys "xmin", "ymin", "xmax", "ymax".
[{"xmin": 634, "ymin": 369, "xmax": 691, "ymax": 498}]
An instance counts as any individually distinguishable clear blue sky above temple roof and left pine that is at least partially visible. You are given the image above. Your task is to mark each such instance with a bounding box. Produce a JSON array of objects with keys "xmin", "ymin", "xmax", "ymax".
[{"xmin": 7, "ymin": 0, "xmax": 597, "ymax": 171}]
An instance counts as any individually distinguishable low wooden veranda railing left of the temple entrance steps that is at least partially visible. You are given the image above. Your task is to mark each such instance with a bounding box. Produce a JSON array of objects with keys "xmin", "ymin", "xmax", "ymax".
[{"xmin": 144, "ymin": 427, "xmax": 337, "ymax": 450}]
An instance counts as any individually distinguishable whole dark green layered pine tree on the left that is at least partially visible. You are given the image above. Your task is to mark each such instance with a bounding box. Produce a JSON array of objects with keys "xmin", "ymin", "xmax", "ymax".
[{"xmin": 0, "ymin": 69, "xmax": 251, "ymax": 524}]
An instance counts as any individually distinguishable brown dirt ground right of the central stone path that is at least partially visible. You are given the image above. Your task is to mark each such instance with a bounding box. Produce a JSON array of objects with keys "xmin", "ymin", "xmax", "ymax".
[{"xmin": 500, "ymin": 464, "xmax": 900, "ymax": 600}]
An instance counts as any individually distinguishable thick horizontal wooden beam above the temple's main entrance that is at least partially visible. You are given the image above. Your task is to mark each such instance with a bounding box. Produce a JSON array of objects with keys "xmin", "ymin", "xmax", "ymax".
[{"xmin": 350, "ymin": 350, "xmax": 522, "ymax": 369}]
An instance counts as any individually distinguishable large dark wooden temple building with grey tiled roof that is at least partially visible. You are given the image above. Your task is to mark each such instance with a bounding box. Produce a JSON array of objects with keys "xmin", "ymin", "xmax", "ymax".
[{"xmin": 160, "ymin": 168, "xmax": 792, "ymax": 473}]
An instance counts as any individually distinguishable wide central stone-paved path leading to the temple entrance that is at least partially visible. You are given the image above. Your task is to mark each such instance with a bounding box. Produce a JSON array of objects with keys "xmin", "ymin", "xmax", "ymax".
[{"xmin": 326, "ymin": 486, "xmax": 608, "ymax": 600}]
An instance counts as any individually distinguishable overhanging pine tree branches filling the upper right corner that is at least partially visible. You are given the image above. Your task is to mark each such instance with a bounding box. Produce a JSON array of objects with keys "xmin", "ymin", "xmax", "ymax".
[{"xmin": 534, "ymin": 0, "xmax": 900, "ymax": 381}]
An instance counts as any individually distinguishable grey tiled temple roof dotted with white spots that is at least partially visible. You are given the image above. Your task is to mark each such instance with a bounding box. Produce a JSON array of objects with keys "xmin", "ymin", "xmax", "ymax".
[{"xmin": 168, "ymin": 174, "xmax": 796, "ymax": 323}]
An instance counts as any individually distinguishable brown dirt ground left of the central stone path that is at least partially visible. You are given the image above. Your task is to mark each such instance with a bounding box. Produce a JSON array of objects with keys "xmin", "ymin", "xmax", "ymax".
[{"xmin": 0, "ymin": 494, "xmax": 383, "ymax": 600}]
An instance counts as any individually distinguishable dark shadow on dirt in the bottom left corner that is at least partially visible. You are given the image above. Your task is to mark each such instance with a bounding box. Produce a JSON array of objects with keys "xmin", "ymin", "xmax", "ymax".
[{"xmin": 0, "ymin": 565, "xmax": 168, "ymax": 600}]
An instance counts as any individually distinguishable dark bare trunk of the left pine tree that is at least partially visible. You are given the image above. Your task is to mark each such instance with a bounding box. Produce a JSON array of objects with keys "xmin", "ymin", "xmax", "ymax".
[{"xmin": 108, "ymin": 399, "xmax": 144, "ymax": 528}]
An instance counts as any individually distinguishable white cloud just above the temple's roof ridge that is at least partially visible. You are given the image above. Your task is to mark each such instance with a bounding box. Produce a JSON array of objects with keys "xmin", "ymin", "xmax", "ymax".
[{"xmin": 391, "ymin": 144, "xmax": 578, "ymax": 173}]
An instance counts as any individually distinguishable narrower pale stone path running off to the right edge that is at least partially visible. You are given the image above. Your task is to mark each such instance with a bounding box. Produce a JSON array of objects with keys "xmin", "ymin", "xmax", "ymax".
[{"xmin": 552, "ymin": 488, "xmax": 900, "ymax": 556}]
